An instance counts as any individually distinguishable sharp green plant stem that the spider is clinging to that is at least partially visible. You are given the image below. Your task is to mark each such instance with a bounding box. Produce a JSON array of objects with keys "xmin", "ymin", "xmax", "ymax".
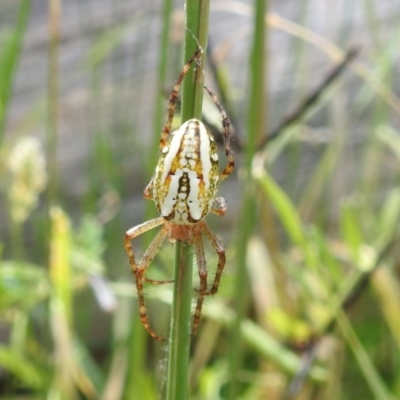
[{"xmin": 166, "ymin": 0, "xmax": 210, "ymax": 400}]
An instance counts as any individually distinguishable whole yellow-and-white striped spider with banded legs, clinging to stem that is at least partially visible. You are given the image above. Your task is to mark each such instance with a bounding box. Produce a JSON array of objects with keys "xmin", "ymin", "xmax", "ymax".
[{"xmin": 124, "ymin": 48, "xmax": 235, "ymax": 340}]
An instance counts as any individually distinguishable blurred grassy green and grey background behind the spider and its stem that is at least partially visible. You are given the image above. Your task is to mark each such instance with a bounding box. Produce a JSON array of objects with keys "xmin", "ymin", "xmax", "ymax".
[{"xmin": 0, "ymin": 0, "xmax": 400, "ymax": 400}]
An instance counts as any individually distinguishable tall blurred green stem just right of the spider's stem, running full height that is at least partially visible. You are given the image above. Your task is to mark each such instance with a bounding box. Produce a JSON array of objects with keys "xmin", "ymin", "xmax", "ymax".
[{"xmin": 228, "ymin": 0, "xmax": 267, "ymax": 399}]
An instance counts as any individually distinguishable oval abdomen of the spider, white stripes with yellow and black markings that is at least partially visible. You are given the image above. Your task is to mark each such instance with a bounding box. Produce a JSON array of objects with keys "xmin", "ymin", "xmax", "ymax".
[{"xmin": 153, "ymin": 119, "xmax": 219, "ymax": 225}]
